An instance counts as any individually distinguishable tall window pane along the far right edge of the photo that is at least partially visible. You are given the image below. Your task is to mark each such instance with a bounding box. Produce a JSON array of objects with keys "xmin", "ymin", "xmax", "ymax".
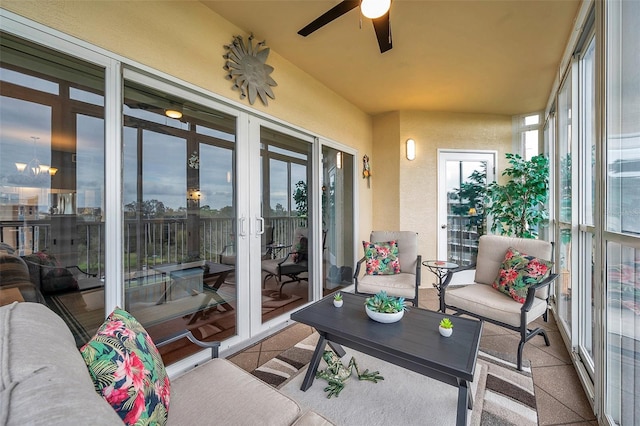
[{"xmin": 603, "ymin": 1, "xmax": 640, "ymax": 425}]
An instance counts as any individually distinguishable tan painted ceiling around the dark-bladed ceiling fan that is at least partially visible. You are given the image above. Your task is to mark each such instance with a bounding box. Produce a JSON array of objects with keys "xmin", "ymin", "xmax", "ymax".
[{"xmin": 202, "ymin": 0, "xmax": 580, "ymax": 115}]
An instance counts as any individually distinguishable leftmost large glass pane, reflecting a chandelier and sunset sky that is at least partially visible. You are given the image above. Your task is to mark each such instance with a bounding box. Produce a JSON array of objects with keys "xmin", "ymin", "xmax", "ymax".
[{"xmin": 0, "ymin": 33, "xmax": 105, "ymax": 346}]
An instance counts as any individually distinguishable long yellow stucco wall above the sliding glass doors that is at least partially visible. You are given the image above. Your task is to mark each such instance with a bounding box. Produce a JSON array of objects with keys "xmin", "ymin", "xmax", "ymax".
[{"xmin": 2, "ymin": 0, "xmax": 372, "ymax": 243}]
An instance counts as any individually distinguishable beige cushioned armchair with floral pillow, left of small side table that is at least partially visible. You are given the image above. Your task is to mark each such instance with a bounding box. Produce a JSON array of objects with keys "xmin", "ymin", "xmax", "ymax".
[{"xmin": 354, "ymin": 231, "xmax": 422, "ymax": 306}]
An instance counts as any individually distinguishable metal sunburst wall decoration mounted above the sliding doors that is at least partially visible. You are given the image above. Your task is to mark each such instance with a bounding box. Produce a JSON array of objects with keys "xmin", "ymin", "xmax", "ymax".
[{"xmin": 223, "ymin": 34, "xmax": 278, "ymax": 105}]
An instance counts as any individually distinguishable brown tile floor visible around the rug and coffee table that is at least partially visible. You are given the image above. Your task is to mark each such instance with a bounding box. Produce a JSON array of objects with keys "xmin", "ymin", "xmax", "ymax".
[{"xmin": 228, "ymin": 289, "xmax": 598, "ymax": 426}]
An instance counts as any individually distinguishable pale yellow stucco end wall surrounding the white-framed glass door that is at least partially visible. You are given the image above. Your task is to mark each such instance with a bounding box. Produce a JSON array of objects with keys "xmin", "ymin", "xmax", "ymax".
[{"xmin": 372, "ymin": 111, "xmax": 512, "ymax": 270}]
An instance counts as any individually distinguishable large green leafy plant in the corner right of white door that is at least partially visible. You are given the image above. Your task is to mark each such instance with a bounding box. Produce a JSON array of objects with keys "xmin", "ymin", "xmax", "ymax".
[{"xmin": 485, "ymin": 154, "xmax": 549, "ymax": 238}]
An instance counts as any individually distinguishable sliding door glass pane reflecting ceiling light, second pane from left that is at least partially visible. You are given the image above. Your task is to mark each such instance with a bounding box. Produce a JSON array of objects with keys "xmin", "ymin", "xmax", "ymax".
[{"xmin": 122, "ymin": 80, "xmax": 239, "ymax": 362}]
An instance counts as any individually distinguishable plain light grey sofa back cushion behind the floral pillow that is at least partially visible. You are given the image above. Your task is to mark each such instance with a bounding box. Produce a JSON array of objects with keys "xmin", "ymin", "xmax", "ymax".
[{"xmin": 0, "ymin": 302, "xmax": 122, "ymax": 426}]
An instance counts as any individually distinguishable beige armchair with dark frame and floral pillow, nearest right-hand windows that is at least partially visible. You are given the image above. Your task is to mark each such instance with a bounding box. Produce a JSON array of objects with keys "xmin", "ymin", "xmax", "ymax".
[{"xmin": 440, "ymin": 235, "xmax": 558, "ymax": 370}]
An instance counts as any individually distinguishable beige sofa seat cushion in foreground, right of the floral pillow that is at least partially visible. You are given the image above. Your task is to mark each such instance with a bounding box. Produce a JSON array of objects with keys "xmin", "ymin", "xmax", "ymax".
[{"xmin": 169, "ymin": 358, "xmax": 301, "ymax": 425}]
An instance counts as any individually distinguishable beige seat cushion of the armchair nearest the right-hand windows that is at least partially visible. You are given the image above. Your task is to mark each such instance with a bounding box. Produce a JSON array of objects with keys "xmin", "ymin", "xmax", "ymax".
[{"xmin": 445, "ymin": 283, "xmax": 547, "ymax": 327}]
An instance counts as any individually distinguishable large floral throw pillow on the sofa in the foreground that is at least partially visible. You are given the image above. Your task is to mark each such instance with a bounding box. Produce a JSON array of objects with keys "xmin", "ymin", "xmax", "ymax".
[{"xmin": 80, "ymin": 308, "xmax": 170, "ymax": 425}]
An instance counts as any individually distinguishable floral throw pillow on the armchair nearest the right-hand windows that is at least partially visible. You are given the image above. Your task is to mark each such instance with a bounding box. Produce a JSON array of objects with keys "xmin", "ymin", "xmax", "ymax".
[{"xmin": 493, "ymin": 247, "xmax": 553, "ymax": 303}]
